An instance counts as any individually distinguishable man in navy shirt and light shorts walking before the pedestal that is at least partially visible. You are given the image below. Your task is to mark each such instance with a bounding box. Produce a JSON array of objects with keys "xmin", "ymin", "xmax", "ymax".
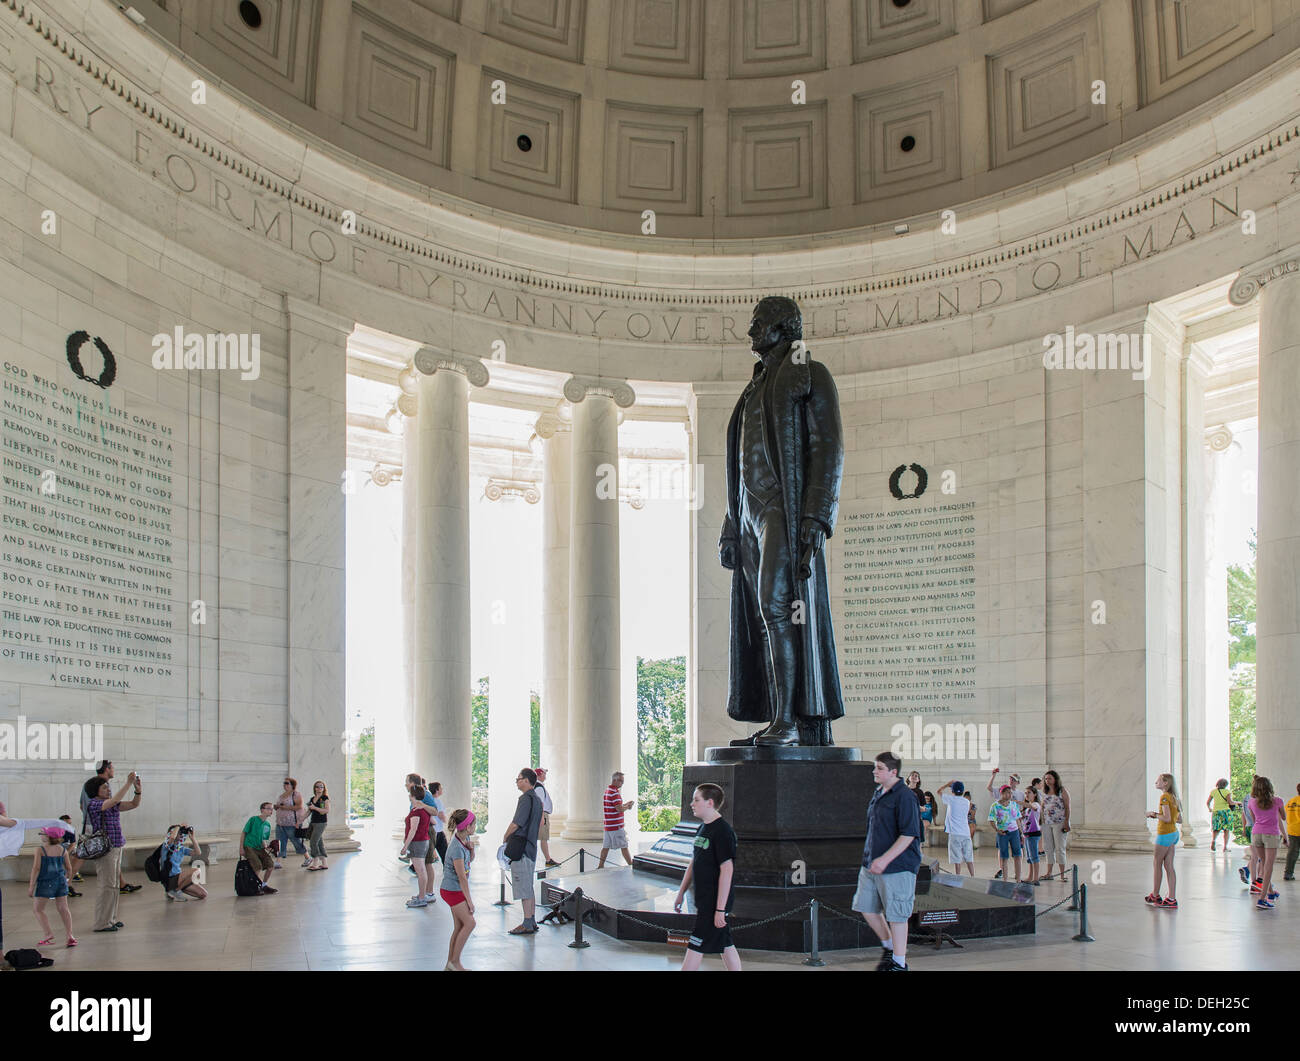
[{"xmin": 853, "ymin": 752, "xmax": 920, "ymax": 973}]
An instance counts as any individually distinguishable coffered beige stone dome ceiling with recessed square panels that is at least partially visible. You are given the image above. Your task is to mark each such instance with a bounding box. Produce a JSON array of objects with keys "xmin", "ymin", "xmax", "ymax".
[{"xmin": 137, "ymin": 0, "xmax": 1297, "ymax": 239}]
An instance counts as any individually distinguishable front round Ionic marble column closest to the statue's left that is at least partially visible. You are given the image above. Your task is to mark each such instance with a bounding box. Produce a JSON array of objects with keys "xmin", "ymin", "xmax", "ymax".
[{"xmin": 564, "ymin": 376, "xmax": 636, "ymax": 840}]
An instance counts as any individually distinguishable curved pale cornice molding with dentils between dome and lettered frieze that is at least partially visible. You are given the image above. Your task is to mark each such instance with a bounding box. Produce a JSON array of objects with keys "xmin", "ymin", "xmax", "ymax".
[{"xmin": 0, "ymin": 0, "xmax": 1300, "ymax": 308}]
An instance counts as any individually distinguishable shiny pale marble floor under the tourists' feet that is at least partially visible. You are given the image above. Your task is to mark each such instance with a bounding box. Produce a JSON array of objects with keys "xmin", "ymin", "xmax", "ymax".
[{"xmin": 0, "ymin": 827, "xmax": 1300, "ymax": 971}]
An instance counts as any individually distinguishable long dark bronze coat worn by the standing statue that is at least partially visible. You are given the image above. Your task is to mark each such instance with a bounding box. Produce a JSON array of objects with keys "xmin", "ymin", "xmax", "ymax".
[{"xmin": 722, "ymin": 354, "xmax": 844, "ymax": 744}]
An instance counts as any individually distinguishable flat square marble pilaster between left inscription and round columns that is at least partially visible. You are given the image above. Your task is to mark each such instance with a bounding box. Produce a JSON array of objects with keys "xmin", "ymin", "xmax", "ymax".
[{"xmin": 285, "ymin": 296, "xmax": 358, "ymax": 852}]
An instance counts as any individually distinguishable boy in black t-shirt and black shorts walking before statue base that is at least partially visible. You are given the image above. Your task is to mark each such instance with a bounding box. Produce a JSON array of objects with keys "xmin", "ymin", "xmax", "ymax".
[{"xmin": 673, "ymin": 784, "xmax": 740, "ymax": 973}]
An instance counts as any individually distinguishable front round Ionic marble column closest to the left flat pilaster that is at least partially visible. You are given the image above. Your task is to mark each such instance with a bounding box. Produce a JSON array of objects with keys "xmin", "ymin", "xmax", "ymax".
[{"xmin": 404, "ymin": 346, "xmax": 489, "ymax": 806}]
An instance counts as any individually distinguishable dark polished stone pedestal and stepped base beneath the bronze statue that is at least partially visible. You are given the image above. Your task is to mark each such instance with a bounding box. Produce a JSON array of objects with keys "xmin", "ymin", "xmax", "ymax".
[{"xmin": 542, "ymin": 746, "xmax": 1036, "ymax": 960}]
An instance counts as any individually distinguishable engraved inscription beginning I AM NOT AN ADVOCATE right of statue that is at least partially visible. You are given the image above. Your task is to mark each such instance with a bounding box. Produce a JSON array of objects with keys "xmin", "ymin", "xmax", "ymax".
[{"xmin": 836, "ymin": 498, "xmax": 984, "ymax": 715}]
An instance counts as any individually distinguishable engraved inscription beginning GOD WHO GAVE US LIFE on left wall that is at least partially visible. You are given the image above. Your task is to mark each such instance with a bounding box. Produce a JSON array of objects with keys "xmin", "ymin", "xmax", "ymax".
[{"xmin": 0, "ymin": 358, "xmax": 189, "ymax": 696}]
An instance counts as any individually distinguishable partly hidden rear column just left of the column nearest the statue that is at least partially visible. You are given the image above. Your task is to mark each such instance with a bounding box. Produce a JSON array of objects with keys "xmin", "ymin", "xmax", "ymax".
[{"xmin": 534, "ymin": 404, "xmax": 573, "ymax": 835}]
